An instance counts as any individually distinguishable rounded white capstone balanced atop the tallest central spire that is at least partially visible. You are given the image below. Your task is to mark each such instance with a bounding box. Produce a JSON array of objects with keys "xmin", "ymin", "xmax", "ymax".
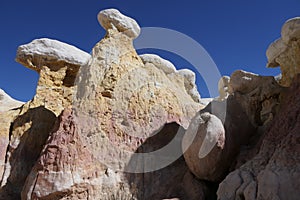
[{"xmin": 98, "ymin": 9, "xmax": 141, "ymax": 39}]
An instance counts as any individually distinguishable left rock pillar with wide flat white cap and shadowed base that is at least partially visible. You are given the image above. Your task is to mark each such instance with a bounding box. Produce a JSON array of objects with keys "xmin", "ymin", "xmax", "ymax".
[{"xmin": 0, "ymin": 39, "xmax": 89, "ymax": 199}]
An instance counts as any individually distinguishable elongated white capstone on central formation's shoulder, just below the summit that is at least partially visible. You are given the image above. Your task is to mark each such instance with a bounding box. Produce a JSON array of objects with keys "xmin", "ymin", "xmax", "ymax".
[{"xmin": 139, "ymin": 54, "xmax": 176, "ymax": 74}]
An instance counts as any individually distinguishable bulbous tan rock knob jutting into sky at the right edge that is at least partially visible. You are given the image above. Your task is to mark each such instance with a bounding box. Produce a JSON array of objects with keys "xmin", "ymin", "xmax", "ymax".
[{"xmin": 266, "ymin": 17, "xmax": 300, "ymax": 86}]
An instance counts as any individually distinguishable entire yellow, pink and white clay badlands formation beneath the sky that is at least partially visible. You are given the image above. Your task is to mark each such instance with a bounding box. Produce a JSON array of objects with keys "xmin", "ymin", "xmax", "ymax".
[{"xmin": 0, "ymin": 9, "xmax": 300, "ymax": 200}]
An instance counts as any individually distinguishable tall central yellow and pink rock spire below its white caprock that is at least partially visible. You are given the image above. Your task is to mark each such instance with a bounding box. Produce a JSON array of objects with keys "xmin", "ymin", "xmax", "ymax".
[{"xmin": 22, "ymin": 7, "xmax": 205, "ymax": 199}]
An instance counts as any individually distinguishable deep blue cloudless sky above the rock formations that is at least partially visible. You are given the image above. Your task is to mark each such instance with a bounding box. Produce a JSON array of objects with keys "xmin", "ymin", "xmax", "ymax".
[{"xmin": 0, "ymin": 0, "xmax": 300, "ymax": 101}]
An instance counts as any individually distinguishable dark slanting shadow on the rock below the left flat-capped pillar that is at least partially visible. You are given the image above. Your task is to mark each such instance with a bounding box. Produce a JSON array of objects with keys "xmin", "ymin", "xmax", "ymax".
[{"xmin": 0, "ymin": 106, "xmax": 56, "ymax": 200}]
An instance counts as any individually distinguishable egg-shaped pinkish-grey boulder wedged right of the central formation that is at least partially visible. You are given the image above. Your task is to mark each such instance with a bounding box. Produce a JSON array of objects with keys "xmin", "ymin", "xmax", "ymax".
[{"xmin": 182, "ymin": 112, "xmax": 225, "ymax": 181}]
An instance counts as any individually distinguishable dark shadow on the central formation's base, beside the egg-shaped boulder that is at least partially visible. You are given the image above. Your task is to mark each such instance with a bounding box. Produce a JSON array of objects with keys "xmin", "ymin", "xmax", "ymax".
[{"xmin": 125, "ymin": 123, "xmax": 215, "ymax": 200}]
